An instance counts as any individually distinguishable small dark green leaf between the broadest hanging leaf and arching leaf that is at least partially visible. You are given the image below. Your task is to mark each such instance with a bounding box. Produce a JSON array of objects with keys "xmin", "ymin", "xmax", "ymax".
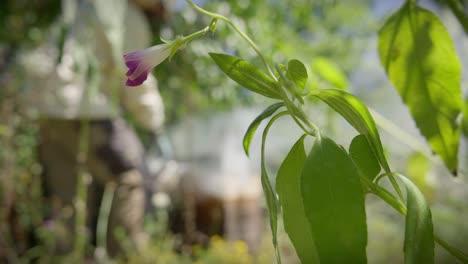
[{"xmin": 349, "ymin": 135, "xmax": 380, "ymax": 181}]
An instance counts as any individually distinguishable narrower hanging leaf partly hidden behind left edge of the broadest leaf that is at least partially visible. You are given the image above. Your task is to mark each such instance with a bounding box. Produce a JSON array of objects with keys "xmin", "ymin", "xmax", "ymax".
[{"xmin": 276, "ymin": 136, "xmax": 319, "ymax": 263}]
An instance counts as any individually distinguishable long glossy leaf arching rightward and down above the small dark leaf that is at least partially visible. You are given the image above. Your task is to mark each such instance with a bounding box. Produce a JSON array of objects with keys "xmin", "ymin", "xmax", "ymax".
[{"xmin": 313, "ymin": 89, "xmax": 391, "ymax": 172}]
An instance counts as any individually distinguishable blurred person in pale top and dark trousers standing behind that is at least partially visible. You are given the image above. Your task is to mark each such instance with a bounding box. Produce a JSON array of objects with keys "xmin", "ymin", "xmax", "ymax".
[{"xmin": 18, "ymin": 0, "xmax": 168, "ymax": 255}]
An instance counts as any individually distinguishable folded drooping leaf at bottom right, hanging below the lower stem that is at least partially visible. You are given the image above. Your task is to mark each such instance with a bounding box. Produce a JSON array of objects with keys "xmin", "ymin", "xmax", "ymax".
[{"xmin": 400, "ymin": 176, "xmax": 434, "ymax": 264}]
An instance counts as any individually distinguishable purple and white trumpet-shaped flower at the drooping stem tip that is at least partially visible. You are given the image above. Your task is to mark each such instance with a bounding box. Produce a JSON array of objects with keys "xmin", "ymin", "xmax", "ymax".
[{"xmin": 124, "ymin": 44, "xmax": 171, "ymax": 86}]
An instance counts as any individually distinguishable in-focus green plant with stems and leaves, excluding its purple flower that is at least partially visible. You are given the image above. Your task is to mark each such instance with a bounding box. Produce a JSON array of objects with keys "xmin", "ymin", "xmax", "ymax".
[{"xmin": 125, "ymin": 0, "xmax": 468, "ymax": 263}]
